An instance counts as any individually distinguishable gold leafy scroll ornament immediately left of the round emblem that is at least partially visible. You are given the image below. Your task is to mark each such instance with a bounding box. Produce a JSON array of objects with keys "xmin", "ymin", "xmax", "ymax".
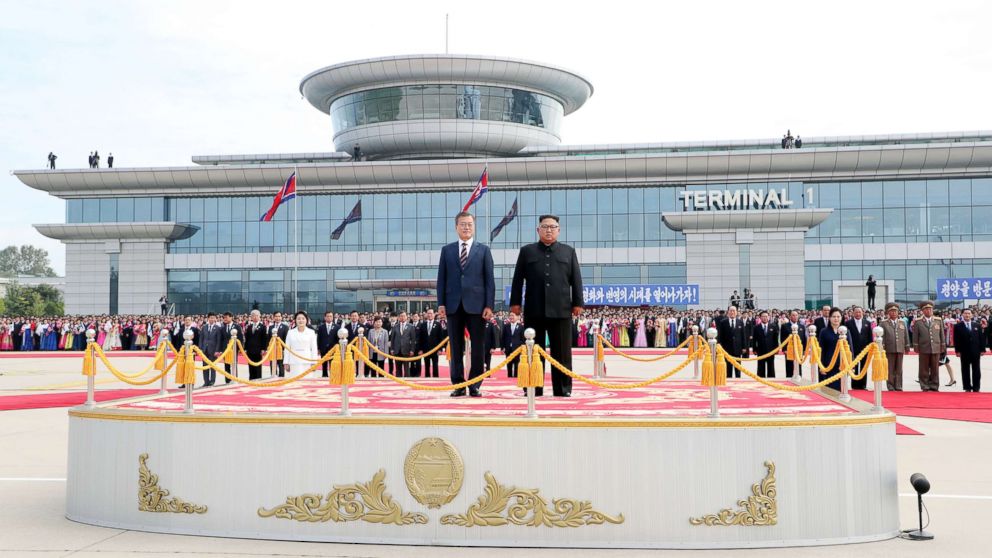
[{"xmin": 258, "ymin": 469, "xmax": 427, "ymax": 525}]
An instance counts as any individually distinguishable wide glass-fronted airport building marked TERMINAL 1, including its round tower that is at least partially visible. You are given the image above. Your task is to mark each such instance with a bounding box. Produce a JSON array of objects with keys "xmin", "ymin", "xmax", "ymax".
[{"xmin": 15, "ymin": 55, "xmax": 992, "ymax": 314}]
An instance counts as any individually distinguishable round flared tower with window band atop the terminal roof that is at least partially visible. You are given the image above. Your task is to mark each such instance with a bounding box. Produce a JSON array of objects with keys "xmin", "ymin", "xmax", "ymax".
[{"xmin": 300, "ymin": 54, "xmax": 593, "ymax": 159}]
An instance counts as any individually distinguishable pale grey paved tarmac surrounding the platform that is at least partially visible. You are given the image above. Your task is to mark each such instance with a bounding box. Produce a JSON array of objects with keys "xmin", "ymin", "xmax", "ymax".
[{"xmin": 0, "ymin": 356, "xmax": 992, "ymax": 558}]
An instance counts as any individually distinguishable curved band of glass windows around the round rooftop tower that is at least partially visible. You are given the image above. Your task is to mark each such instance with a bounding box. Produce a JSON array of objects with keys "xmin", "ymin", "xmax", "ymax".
[{"xmin": 331, "ymin": 85, "xmax": 564, "ymax": 133}]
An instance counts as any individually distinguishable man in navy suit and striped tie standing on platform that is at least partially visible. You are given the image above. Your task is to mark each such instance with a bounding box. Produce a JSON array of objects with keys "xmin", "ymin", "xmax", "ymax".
[{"xmin": 437, "ymin": 211, "xmax": 496, "ymax": 397}]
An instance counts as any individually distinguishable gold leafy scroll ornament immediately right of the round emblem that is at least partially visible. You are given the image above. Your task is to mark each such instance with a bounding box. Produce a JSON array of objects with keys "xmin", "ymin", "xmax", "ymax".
[{"xmin": 441, "ymin": 472, "xmax": 624, "ymax": 527}]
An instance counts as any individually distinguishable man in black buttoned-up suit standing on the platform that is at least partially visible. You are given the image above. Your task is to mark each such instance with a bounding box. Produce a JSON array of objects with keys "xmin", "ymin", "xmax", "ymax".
[{"xmin": 510, "ymin": 215, "xmax": 585, "ymax": 397}]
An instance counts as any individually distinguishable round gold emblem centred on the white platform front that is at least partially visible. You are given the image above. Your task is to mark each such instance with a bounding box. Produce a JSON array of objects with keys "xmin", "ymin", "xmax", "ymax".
[{"xmin": 403, "ymin": 438, "xmax": 465, "ymax": 508}]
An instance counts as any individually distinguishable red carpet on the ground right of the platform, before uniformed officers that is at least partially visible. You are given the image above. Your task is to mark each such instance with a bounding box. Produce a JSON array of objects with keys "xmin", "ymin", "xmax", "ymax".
[{"xmin": 851, "ymin": 390, "xmax": 992, "ymax": 423}]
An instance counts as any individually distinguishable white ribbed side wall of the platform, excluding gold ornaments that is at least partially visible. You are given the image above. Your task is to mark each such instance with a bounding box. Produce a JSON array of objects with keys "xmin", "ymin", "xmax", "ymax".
[{"xmin": 66, "ymin": 409, "xmax": 898, "ymax": 548}]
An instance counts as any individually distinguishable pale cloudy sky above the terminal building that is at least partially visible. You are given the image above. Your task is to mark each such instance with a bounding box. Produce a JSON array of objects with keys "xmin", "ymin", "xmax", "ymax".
[{"xmin": 0, "ymin": 0, "xmax": 992, "ymax": 274}]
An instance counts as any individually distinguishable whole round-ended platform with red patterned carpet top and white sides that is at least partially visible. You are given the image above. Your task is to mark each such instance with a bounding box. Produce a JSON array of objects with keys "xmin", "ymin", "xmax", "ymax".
[{"xmin": 67, "ymin": 379, "xmax": 898, "ymax": 548}]
